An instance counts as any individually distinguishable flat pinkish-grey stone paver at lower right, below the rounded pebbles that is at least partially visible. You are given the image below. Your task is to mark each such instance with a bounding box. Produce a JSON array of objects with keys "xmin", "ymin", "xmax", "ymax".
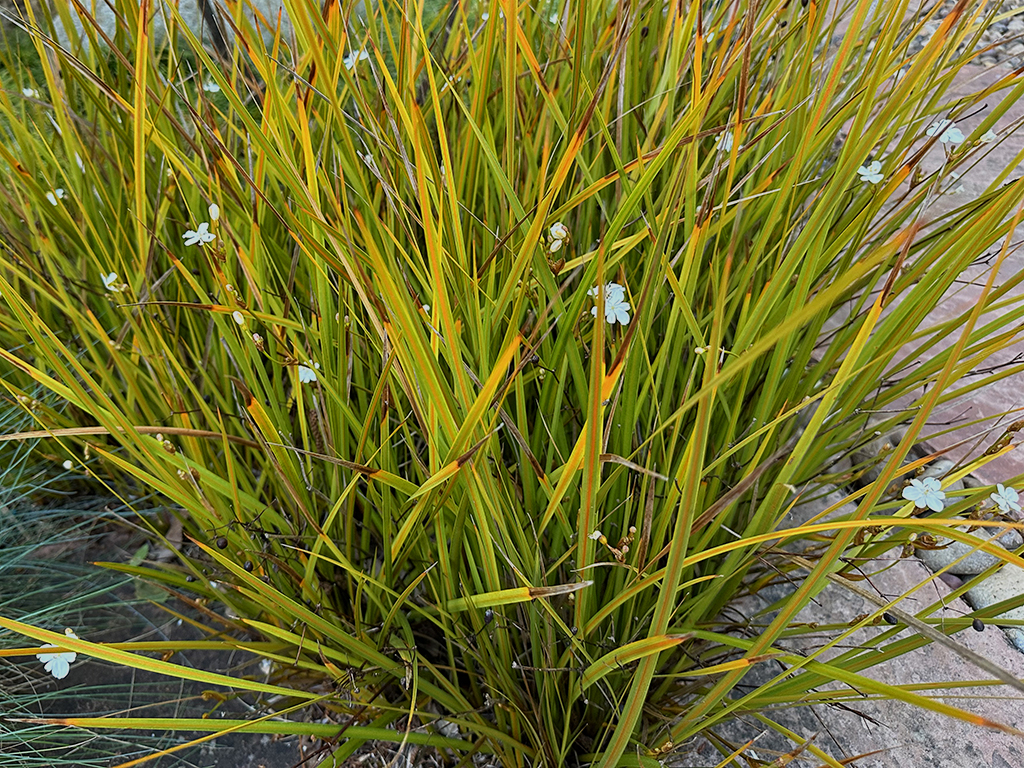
[{"xmin": 667, "ymin": 490, "xmax": 1024, "ymax": 768}]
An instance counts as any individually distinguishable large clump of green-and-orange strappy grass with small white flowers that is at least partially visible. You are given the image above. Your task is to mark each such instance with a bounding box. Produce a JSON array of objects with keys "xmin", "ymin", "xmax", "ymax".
[{"xmin": 0, "ymin": 0, "xmax": 1024, "ymax": 768}]
